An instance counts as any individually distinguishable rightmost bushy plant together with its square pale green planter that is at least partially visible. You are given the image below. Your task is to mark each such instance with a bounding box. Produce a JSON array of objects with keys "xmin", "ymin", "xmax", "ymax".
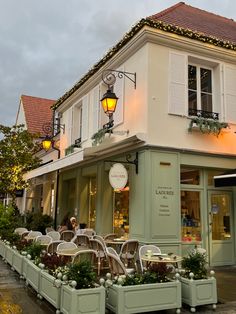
[{"xmin": 180, "ymin": 249, "xmax": 217, "ymax": 312}]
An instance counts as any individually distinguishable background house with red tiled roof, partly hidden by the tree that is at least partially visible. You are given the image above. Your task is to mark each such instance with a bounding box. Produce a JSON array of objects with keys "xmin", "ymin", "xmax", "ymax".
[{"xmin": 16, "ymin": 95, "xmax": 57, "ymax": 214}]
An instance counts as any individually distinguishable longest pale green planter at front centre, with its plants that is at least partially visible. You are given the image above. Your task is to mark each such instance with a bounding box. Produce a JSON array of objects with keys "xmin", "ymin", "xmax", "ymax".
[{"xmin": 106, "ymin": 263, "xmax": 181, "ymax": 314}]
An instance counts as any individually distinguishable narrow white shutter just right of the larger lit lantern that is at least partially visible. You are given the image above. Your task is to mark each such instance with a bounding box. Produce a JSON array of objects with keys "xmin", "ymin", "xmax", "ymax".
[{"xmin": 113, "ymin": 69, "xmax": 125, "ymax": 125}]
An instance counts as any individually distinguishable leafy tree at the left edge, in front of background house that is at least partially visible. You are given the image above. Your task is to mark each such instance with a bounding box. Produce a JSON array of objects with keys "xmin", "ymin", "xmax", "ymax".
[{"xmin": 0, "ymin": 124, "xmax": 40, "ymax": 205}]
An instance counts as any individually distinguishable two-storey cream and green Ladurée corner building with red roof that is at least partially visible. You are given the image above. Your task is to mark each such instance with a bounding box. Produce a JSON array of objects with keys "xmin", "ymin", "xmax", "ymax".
[{"xmin": 27, "ymin": 2, "xmax": 236, "ymax": 266}]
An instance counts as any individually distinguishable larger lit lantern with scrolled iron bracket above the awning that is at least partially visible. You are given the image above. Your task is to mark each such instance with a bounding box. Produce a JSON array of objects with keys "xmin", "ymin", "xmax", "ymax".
[{"xmin": 101, "ymin": 69, "xmax": 136, "ymax": 132}]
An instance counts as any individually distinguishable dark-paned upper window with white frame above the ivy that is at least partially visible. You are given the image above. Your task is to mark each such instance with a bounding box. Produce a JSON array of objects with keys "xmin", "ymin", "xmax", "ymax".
[{"xmin": 188, "ymin": 64, "xmax": 213, "ymax": 116}]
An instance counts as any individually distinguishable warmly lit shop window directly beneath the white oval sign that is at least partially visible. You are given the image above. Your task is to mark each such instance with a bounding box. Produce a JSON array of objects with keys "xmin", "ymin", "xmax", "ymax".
[{"xmin": 113, "ymin": 186, "xmax": 129, "ymax": 236}]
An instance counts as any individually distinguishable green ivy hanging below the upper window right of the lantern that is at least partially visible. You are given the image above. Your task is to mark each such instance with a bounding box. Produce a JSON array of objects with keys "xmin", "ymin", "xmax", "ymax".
[{"xmin": 188, "ymin": 117, "xmax": 229, "ymax": 136}]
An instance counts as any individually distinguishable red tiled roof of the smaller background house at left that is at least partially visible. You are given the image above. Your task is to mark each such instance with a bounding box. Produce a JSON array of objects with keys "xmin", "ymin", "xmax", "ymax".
[{"xmin": 21, "ymin": 95, "xmax": 55, "ymax": 136}]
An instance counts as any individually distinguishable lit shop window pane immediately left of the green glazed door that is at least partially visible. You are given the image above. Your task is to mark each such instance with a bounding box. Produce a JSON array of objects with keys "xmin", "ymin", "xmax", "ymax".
[{"xmin": 181, "ymin": 191, "xmax": 201, "ymax": 242}]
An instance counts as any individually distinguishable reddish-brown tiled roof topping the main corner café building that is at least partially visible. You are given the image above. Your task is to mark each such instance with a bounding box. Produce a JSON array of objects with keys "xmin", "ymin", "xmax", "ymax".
[{"xmin": 148, "ymin": 2, "xmax": 236, "ymax": 43}]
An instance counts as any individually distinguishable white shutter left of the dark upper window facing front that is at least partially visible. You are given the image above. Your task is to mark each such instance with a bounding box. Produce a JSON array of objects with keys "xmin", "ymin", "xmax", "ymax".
[{"xmin": 169, "ymin": 52, "xmax": 188, "ymax": 115}]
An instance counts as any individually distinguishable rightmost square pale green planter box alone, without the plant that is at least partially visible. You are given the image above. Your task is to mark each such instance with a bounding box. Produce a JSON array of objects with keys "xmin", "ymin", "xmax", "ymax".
[{"xmin": 180, "ymin": 272, "xmax": 217, "ymax": 312}]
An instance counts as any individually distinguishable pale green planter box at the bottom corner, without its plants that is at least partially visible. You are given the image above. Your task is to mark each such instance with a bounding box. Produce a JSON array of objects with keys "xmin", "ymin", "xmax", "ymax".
[{"xmin": 61, "ymin": 285, "xmax": 105, "ymax": 314}]
